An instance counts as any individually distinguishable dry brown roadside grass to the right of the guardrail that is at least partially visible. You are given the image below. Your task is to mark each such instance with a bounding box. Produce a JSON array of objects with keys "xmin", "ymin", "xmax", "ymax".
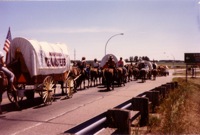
[{"xmin": 147, "ymin": 78, "xmax": 200, "ymax": 134}]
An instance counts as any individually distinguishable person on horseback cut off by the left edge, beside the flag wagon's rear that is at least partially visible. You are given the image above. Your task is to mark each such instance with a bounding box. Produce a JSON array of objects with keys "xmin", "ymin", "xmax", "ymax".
[{"xmin": 0, "ymin": 51, "xmax": 16, "ymax": 91}]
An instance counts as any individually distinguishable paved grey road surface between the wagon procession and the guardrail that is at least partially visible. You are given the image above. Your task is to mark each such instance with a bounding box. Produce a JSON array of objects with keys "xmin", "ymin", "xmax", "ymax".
[{"xmin": 0, "ymin": 73, "xmax": 172, "ymax": 135}]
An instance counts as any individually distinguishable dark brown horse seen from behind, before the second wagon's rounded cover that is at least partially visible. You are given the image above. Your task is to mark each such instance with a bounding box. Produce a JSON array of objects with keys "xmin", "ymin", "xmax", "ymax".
[{"xmin": 103, "ymin": 68, "xmax": 114, "ymax": 90}]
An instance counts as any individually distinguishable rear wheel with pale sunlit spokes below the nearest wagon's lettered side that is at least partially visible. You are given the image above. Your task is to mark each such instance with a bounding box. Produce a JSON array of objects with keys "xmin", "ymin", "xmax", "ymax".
[{"xmin": 39, "ymin": 76, "xmax": 54, "ymax": 105}]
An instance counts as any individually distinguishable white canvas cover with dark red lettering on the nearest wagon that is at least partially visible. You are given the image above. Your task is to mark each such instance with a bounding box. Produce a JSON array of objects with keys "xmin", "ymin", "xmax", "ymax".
[{"xmin": 7, "ymin": 37, "xmax": 70, "ymax": 77}]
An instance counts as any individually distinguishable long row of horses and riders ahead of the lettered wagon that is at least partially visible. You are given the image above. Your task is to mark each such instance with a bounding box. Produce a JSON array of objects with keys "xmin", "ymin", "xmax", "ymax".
[{"xmin": 67, "ymin": 62, "xmax": 166, "ymax": 90}]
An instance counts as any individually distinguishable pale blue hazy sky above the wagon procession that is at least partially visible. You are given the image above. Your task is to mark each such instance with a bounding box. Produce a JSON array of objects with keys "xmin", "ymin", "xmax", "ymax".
[{"xmin": 0, "ymin": 0, "xmax": 200, "ymax": 60}]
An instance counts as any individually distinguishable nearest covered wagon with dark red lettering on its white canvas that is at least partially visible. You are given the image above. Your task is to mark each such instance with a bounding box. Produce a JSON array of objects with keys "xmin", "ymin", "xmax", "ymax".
[{"xmin": 7, "ymin": 37, "xmax": 70, "ymax": 103}]
